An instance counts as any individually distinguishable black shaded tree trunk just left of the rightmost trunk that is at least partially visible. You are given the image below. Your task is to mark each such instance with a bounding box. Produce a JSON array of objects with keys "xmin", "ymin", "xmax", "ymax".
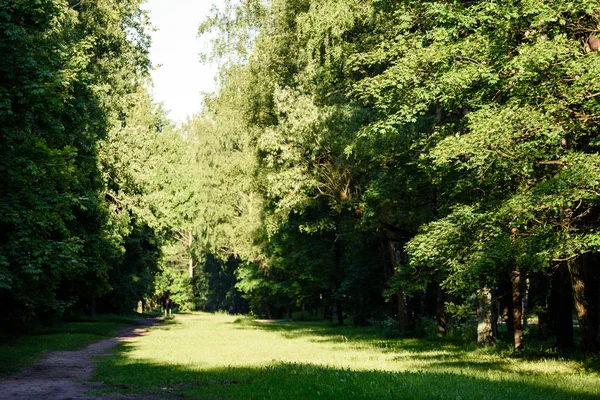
[{"xmin": 550, "ymin": 263, "xmax": 575, "ymax": 349}]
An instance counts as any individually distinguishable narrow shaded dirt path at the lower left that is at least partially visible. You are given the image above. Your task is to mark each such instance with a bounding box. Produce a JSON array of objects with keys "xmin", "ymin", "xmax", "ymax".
[{"xmin": 0, "ymin": 319, "xmax": 160, "ymax": 400}]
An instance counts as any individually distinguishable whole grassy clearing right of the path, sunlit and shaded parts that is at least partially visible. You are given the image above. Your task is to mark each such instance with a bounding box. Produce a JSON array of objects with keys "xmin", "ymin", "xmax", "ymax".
[{"xmin": 96, "ymin": 314, "xmax": 600, "ymax": 400}]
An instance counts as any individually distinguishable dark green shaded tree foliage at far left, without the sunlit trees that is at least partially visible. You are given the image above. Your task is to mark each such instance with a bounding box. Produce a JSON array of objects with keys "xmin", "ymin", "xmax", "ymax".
[{"xmin": 0, "ymin": 0, "xmax": 149, "ymax": 320}]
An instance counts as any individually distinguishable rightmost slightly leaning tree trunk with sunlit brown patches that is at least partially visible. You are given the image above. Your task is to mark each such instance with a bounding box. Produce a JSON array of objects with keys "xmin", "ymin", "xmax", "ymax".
[{"xmin": 568, "ymin": 257, "xmax": 600, "ymax": 353}]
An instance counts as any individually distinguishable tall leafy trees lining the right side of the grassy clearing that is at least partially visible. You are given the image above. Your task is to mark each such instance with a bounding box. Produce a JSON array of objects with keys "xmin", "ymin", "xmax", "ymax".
[{"xmin": 188, "ymin": 0, "xmax": 600, "ymax": 351}]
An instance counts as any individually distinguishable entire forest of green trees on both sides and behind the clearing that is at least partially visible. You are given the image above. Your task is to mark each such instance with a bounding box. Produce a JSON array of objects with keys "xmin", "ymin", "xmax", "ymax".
[{"xmin": 0, "ymin": 0, "xmax": 600, "ymax": 353}]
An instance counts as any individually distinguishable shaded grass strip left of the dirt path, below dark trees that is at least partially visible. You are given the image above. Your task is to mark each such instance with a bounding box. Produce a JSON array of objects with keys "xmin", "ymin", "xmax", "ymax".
[{"xmin": 0, "ymin": 315, "xmax": 147, "ymax": 376}]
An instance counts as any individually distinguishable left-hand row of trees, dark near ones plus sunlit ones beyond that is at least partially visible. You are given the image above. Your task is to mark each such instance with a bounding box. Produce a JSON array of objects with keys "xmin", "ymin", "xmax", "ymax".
[{"xmin": 0, "ymin": 0, "xmax": 213, "ymax": 327}]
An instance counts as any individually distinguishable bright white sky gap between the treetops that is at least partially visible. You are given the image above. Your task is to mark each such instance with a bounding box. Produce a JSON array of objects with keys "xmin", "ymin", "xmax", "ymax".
[{"xmin": 144, "ymin": 0, "xmax": 224, "ymax": 122}]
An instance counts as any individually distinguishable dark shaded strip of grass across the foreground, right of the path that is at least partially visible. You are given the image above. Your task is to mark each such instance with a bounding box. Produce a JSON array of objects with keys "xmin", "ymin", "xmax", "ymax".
[{"xmin": 97, "ymin": 344, "xmax": 598, "ymax": 400}]
